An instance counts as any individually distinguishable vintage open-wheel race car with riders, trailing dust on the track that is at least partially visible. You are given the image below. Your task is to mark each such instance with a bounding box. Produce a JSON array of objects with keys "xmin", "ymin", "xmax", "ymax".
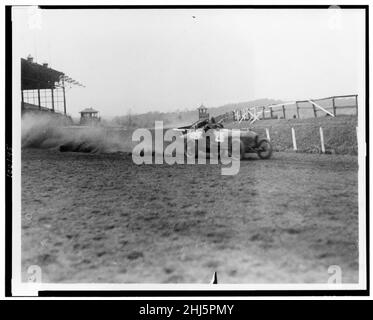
[{"xmin": 179, "ymin": 120, "xmax": 272, "ymax": 160}]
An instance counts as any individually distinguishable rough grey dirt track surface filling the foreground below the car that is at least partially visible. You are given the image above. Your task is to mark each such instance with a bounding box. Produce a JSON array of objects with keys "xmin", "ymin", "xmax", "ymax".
[{"xmin": 22, "ymin": 149, "xmax": 358, "ymax": 283}]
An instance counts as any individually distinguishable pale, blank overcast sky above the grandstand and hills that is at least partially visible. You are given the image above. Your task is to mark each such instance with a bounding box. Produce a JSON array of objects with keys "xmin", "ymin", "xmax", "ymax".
[{"xmin": 13, "ymin": 8, "xmax": 365, "ymax": 116}]
